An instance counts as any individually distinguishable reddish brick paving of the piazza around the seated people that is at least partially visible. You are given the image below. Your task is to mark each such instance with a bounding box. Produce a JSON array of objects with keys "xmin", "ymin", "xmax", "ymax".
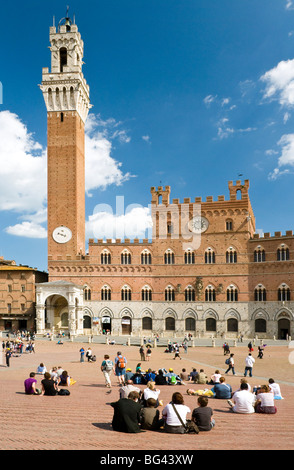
[{"xmin": 0, "ymin": 340, "xmax": 294, "ymax": 452}]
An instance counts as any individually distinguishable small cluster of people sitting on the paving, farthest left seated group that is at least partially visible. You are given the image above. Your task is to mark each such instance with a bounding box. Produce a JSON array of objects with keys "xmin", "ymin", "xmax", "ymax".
[{"xmin": 24, "ymin": 363, "xmax": 76, "ymax": 396}]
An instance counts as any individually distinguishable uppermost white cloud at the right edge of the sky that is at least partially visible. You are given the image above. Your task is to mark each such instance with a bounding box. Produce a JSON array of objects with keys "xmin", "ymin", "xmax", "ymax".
[{"xmin": 260, "ymin": 59, "xmax": 294, "ymax": 107}]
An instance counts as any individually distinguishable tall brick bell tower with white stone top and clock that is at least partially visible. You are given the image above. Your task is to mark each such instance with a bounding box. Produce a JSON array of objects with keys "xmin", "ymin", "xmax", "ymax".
[{"xmin": 40, "ymin": 12, "xmax": 90, "ymax": 260}]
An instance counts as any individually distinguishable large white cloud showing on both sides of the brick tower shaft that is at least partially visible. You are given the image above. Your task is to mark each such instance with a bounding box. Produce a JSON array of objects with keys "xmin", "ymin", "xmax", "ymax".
[{"xmin": 0, "ymin": 110, "xmax": 131, "ymax": 238}]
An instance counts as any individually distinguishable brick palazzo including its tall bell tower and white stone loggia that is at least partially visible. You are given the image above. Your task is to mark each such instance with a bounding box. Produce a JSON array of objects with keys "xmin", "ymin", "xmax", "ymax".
[{"xmin": 36, "ymin": 14, "xmax": 294, "ymax": 339}]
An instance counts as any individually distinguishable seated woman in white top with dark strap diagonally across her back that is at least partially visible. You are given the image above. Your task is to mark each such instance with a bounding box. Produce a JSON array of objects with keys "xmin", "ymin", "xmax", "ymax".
[{"xmin": 162, "ymin": 392, "xmax": 191, "ymax": 434}]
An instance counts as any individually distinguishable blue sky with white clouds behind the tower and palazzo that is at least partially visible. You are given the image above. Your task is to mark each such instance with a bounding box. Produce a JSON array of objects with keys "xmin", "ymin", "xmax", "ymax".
[{"xmin": 0, "ymin": 0, "xmax": 294, "ymax": 270}]
